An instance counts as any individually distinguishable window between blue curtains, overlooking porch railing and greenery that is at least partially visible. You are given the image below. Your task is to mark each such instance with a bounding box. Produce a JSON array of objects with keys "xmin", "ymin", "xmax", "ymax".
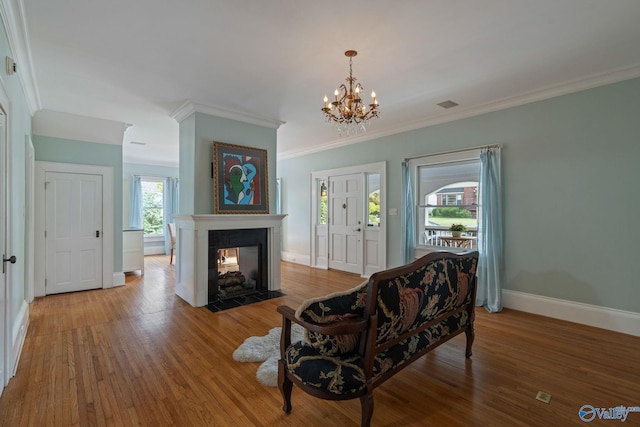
[{"xmin": 412, "ymin": 153, "xmax": 480, "ymax": 246}]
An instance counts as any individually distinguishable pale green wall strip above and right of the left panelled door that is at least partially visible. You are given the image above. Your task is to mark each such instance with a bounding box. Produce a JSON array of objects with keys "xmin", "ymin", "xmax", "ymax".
[{"xmin": 33, "ymin": 135, "xmax": 122, "ymax": 272}]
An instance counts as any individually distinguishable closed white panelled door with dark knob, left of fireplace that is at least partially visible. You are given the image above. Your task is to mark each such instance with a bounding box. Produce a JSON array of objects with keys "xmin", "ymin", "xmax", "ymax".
[{"xmin": 45, "ymin": 172, "xmax": 103, "ymax": 295}]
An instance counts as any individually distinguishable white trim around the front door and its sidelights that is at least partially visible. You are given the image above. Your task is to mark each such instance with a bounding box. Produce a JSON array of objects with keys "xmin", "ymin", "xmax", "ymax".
[{"xmin": 309, "ymin": 162, "xmax": 387, "ymax": 277}]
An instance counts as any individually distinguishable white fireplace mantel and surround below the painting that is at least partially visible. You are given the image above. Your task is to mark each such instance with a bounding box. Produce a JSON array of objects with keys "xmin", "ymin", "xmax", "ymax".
[{"xmin": 173, "ymin": 214, "xmax": 286, "ymax": 307}]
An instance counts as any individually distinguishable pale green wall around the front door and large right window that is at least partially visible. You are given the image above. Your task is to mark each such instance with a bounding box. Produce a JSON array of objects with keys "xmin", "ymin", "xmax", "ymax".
[{"xmin": 278, "ymin": 79, "xmax": 640, "ymax": 313}]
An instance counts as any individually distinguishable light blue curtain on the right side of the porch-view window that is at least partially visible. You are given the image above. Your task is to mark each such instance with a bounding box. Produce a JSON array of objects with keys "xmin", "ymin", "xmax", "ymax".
[{"xmin": 476, "ymin": 148, "xmax": 503, "ymax": 313}]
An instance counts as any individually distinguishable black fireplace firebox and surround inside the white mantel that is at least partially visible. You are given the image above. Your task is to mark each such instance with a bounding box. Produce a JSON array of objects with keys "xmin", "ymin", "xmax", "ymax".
[{"xmin": 208, "ymin": 228, "xmax": 269, "ymax": 303}]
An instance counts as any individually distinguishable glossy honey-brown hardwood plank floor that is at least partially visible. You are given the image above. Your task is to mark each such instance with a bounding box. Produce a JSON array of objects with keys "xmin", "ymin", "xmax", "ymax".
[{"xmin": 0, "ymin": 256, "xmax": 640, "ymax": 427}]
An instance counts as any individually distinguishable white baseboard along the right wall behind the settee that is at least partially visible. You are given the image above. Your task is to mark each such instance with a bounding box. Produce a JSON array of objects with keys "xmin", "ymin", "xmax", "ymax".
[{"xmin": 502, "ymin": 289, "xmax": 640, "ymax": 336}]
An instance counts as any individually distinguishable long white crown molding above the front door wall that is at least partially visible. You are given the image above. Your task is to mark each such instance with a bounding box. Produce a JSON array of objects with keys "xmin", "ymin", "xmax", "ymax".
[{"xmin": 278, "ymin": 63, "xmax": 640, "ymax": 160}]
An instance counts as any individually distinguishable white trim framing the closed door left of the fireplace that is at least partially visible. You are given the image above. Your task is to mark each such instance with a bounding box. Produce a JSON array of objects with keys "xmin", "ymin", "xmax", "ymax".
[{"xmin": 34, "ymin": 161, "xmax": 114, "ymax": 296}]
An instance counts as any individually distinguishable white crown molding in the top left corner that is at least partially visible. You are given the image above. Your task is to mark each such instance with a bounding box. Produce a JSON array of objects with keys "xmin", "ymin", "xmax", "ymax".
[{"xmin": 0, "ymin": 0, "xmax": 42, "ymax": 115}]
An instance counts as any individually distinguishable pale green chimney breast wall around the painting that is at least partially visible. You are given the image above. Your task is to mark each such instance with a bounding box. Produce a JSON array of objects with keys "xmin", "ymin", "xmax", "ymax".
[{"xmin": 180, "ymin": 113, "xmax": 277, "ymax": 214}]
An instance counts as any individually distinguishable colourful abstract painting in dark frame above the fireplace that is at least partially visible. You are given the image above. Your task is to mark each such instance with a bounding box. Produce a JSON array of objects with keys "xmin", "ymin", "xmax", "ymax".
[{"xmin": 213, "ymin": 142, "xmax": 269, "ymax": 214}]
